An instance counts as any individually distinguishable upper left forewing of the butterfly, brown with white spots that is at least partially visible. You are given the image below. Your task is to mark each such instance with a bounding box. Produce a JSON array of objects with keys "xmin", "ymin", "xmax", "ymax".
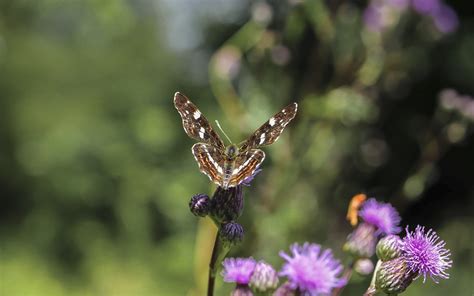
[{"xmin": 174, "ymin": 92, "xmax": 225, "ymax": 150}]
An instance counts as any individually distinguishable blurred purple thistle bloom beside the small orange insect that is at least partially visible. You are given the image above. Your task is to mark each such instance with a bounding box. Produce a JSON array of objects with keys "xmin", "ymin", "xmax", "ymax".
[{"xmin": 359, "ymin": 198, "xmax": 401, "ymax": 234}]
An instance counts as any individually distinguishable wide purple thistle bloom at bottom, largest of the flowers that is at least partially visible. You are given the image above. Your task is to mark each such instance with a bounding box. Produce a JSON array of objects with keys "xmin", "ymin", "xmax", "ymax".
[{"xmin": 279, "ymin": 243, "xmax": 347, "ymax": 296}]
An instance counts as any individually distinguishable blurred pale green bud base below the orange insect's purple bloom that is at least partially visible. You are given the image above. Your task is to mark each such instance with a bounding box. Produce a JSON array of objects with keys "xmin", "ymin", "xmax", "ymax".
[{"xmin": 343, "ymin": 223, "xmax": 377, "ymax": 258}]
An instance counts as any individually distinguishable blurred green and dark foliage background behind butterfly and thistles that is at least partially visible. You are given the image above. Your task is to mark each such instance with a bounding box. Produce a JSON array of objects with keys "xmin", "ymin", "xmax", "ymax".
[{"xmin": 0, "ymin": 0, "xmax": 474, "ymax": 295}]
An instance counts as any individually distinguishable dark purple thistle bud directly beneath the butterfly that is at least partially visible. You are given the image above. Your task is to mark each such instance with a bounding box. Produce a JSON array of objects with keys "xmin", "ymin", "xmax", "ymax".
[{"xmin": 210, "ymin": 185, "xmax": 244, "ymax": 224}]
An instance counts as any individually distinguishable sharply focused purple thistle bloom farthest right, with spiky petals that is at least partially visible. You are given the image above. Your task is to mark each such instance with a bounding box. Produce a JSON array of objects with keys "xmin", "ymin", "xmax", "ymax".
[{"xmin": 403, "ymin": 225, "xmax": 453, "ymax": 283}]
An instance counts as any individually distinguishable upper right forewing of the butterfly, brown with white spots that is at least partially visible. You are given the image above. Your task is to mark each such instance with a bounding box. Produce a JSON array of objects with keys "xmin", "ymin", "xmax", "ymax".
[{"xmin": 239, "ymin": 103, "xmax": 298, "ymax": 151}]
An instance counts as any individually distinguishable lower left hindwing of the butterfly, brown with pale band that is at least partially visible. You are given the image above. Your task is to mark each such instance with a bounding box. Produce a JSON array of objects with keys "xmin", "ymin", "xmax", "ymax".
[{"xmin": 192, "ymin": 143, "xmax": 225, "ymax": 186}]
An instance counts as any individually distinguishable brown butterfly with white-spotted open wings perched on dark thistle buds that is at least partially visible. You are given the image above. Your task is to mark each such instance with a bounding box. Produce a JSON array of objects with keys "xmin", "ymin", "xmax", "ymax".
[{"xmin": 174, "ymin": 92, "xmax": 298, "ymax": 189}]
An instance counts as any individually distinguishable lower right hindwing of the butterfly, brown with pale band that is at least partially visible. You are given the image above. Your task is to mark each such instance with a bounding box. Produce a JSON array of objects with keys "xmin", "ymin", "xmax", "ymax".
[{"xmin": 224, "ymin": 149, "xmax": 265, "ymax": 187}]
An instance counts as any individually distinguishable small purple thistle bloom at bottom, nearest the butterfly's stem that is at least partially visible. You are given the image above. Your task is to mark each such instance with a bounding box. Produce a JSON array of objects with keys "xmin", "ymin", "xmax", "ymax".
[{"xmin": 221, "ymin": 258, "xmax": 257, "ymax": 285}]
